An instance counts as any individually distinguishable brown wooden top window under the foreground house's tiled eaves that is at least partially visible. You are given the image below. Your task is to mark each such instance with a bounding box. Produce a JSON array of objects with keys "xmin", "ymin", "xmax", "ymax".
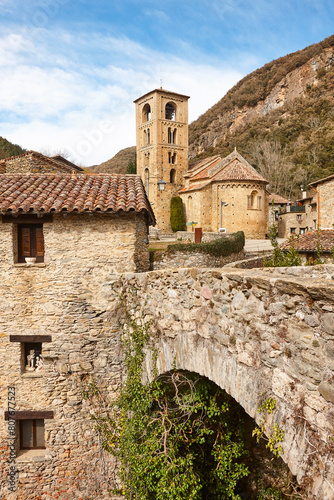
[{"xmin": 17, "ymin": 224, "xmax": 44, "ymax": 262}]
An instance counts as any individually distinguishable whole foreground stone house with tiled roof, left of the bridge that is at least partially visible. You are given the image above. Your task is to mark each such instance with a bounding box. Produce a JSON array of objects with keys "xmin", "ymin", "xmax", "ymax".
[{"xmin": 0, "ymin": 173, "xmax": 155, "ymax": 500}]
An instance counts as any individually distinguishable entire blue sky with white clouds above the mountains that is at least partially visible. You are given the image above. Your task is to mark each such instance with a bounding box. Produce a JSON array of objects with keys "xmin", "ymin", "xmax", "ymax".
[{"xmin": 0, "ymin": 0, "xmax": 334, "ymax": 166}]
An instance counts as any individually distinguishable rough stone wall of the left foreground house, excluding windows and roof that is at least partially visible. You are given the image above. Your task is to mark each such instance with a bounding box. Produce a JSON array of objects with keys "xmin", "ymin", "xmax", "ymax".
[{"xmin": 0, "ymin": 214, "xmax": 148, "ymax": 500}]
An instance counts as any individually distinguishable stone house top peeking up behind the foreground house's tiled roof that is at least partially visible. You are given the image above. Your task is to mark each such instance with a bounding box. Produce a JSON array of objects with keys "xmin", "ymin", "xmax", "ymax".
[{"xmin": 0, "ymin": 151, "xmax": 84, "ymax": 174}]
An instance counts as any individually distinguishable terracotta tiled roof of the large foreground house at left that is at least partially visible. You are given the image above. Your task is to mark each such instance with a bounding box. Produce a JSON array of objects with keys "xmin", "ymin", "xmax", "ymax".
[{"xmin": 0, "ymin": 173, "xmax": 155, "ymax": 224}]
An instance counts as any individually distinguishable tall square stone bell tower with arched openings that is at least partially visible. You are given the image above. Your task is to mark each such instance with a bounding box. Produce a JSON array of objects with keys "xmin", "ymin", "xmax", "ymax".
[{"xmin": 134, "ymin": 88, "xmax": 189, "ymax": 233}]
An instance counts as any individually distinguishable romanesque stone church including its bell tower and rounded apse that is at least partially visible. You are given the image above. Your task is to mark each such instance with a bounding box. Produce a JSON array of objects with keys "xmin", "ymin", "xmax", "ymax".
[{"xmin": 135, "ymin": 88, "xmax": 269, "ymax": 238}]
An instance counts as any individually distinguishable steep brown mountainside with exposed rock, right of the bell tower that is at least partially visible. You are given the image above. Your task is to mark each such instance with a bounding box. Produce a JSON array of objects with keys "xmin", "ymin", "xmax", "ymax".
[{"xmin": 189, "ymin": 35, "xmax": 334, "ymax": 196}]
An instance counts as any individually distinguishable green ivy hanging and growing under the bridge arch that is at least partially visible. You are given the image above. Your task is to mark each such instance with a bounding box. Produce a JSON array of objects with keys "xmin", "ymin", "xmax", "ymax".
[{"xmin": 84, "ymin": 284, "xmax": 249, "ymax": 500}]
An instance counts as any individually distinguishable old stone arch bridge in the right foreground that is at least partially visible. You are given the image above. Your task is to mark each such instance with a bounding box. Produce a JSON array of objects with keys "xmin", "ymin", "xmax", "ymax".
[{"xmin": 118, "ymin": 266, "xmax": 334, "ymax": 500}]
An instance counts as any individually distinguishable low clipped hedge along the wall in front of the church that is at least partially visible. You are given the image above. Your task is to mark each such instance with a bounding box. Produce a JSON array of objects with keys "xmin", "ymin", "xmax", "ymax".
[{"xmin": 167, "ymin": 231, "xmax": 245, "ymax": 257}]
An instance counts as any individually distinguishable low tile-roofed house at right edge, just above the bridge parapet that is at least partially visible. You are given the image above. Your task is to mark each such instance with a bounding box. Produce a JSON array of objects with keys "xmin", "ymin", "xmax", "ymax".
[{"xmin": 280, "ymin": 229, "xmax": 334, "ymax": 264}]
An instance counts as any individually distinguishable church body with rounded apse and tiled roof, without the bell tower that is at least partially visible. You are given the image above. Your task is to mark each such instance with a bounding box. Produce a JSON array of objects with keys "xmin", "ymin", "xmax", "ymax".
[{"xmin": 179, "ymin": 149, "xmax": 268, "ymax": 238}]
